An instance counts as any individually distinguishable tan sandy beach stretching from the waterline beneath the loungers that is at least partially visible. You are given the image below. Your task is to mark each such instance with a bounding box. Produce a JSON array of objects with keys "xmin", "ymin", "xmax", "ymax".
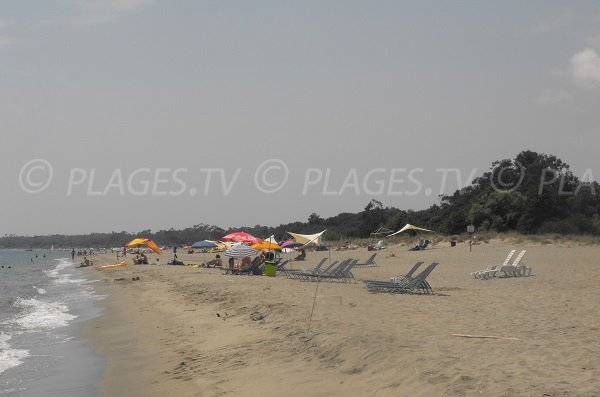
[{"xmin": 82, "ymin": 241, "xmax": 600, "ymax": 397}]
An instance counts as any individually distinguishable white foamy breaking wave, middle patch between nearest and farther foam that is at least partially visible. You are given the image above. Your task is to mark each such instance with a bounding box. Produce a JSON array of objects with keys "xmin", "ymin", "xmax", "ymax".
[{"xmin": 12, "ymin": 298, "xmax": 77, "ymax": 330}]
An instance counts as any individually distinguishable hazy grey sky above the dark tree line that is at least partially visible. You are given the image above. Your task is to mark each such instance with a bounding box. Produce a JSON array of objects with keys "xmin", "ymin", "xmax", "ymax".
[{"xmin": 0, "ymin": 0, "xmax": 600, "ymax": 235}]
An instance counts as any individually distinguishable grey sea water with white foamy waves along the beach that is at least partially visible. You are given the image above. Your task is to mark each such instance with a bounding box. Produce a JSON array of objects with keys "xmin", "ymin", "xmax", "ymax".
[{"xmin": 0, "ymin": 250, "xmax": 105, "ymax": 397}]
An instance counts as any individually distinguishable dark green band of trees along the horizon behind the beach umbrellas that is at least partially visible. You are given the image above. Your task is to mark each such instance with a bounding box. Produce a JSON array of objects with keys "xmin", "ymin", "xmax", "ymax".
[{"xmin": 0, "ymin": 151, "xmax": 600, "ymax": 248}]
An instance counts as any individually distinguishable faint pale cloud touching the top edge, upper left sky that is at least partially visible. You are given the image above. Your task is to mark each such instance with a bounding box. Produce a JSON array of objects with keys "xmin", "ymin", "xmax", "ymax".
[{"xmin": 61, "ymin": 0, "xmax": 154, "ymax": 25}]
